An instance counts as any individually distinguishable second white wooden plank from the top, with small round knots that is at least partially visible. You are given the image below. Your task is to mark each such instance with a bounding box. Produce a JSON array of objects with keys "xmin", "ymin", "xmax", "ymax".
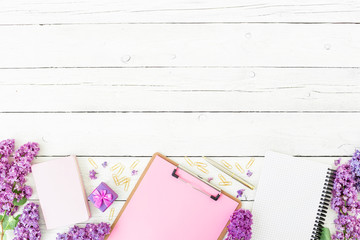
[{"xmin": 0, "ymin": 24, "xmax": 360, "ymax": 68}]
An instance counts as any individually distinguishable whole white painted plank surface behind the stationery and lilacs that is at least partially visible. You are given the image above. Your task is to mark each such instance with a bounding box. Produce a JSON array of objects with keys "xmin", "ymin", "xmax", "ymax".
[{"xmin": 0, "ymin": 0, "xmax": 360, "ymax": 239}]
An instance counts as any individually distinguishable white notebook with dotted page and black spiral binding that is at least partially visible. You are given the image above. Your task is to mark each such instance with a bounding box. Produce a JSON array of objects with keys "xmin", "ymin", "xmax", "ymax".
[{"xmin": 252, "ymin": 152, "xmax": 334, "ymax": 240}]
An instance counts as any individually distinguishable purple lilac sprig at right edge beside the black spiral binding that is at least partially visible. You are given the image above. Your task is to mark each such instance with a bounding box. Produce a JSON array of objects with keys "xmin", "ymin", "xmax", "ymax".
[{"xmin": 331, "ymin": 153, "xmax": 360, "ymax": 240}]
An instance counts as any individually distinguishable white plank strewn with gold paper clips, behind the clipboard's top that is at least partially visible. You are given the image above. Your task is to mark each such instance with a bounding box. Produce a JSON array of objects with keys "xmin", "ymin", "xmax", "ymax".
[{"xmin": 27, "ymin": 156, "xmax": 338, "ymax": 201}]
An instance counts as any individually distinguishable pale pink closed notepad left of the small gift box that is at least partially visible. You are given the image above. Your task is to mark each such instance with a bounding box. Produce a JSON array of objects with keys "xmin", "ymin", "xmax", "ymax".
[{"xmin": 32, "ymin": 156, "xmax": 90, "ymax": 229}]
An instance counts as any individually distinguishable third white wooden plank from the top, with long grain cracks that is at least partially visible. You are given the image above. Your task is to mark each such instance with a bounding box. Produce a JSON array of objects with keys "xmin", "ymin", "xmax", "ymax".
[{"xmin": 0, "ymin": 68, "xmax": 360, "ymax": 112}]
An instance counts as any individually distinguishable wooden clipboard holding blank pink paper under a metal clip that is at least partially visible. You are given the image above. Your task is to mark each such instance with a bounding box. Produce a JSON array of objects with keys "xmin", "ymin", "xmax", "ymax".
[{"xmin": 106, "ymin": 153, "xmax": 241, "ymax": 240}]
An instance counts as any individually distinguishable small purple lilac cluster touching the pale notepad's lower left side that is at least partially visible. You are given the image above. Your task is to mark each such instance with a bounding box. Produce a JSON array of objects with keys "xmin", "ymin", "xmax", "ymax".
[{"xmin": 13, "ymin": 203, "xmax": 41, "ymax": 240}]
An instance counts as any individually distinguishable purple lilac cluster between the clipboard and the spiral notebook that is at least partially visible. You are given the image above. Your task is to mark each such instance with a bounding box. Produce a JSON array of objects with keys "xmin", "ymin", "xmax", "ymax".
[{"xmin": 225, "ymin": 209, "xmax": 253, "ymax": 240}]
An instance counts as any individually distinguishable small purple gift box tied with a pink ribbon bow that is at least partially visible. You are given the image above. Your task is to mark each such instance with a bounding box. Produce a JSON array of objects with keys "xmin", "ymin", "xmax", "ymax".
[{"xmin": 88, "ymin": 182, "xmax": 118, "ymax": 212}]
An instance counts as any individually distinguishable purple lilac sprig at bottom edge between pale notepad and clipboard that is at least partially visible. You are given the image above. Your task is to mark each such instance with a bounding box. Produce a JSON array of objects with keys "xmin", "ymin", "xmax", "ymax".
[{"xmin": 56, "ymin": 222, "xmax": 110, "ymax": 240}]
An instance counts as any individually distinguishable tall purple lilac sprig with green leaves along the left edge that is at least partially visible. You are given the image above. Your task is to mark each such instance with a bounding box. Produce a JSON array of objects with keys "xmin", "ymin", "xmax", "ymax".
[{"xmin": 0, "ymin": 139, "xmax": 40, "ymax": 239}]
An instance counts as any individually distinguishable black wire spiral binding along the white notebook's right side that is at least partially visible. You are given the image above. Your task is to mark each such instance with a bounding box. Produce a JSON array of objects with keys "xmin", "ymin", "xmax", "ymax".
[{"xmin": 310, "ymin": 168, "xmax": 336, "ymax": 240}]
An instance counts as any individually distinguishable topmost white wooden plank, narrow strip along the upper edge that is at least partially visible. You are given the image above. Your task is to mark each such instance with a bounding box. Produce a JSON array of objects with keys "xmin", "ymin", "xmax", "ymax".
[{"xmin": 0, "ymin": 0, "xmax": 360, "ymax": 24}]
